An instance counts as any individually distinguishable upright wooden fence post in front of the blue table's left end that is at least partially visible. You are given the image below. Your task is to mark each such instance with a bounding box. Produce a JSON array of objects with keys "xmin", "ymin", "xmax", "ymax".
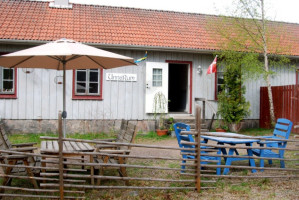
[{"xmin": 195, "ymin": 105, "xmax": 201, "ymax": 192}]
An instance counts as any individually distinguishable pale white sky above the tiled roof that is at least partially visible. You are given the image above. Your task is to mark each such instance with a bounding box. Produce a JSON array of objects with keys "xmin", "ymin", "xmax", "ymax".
[{"xmin": 65, "ymin": 0, "xmax": 299, "ymax": 24}]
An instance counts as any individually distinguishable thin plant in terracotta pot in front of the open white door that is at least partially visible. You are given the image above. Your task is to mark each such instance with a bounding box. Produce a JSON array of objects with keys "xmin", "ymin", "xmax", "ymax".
[{"xmin": 153, "ymin": 92, "xmax": 168, "ymax": 136}]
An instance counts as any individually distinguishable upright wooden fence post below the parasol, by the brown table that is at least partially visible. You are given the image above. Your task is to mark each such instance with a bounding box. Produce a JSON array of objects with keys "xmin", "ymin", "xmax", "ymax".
[{"xmin": 58, "ymin": 111, "xmax": 64, "ymax": 200}]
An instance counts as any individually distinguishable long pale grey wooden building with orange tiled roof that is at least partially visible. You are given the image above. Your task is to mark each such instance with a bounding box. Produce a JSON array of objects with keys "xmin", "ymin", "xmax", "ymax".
[{"xmin": 0, "ymin": 0, "xmax": 299, "ymax": 132}]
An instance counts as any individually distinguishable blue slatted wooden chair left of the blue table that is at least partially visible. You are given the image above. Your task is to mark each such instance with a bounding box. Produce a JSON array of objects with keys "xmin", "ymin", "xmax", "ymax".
[{"xmin": 173, "ymin": 123, "xmax": 221, "ymax": 175}]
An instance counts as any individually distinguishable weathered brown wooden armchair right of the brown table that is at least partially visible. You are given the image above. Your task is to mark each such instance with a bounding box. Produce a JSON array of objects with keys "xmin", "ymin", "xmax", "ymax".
[{"xmin": 94, "ymin": 120, "xmax": 136, "ymax": 185}]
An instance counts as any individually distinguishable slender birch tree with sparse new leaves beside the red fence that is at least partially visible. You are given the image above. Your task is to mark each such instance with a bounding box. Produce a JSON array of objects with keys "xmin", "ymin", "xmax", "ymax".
[{"xmin": 210, "ymin": 0, "xmax": 289, "ymax": 125}]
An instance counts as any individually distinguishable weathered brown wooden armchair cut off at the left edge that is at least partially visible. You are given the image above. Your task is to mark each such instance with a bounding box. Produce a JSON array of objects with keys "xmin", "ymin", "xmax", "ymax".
[{"xmin": 0, "ymin": 122, "xmax": 38, "ymax": 189}]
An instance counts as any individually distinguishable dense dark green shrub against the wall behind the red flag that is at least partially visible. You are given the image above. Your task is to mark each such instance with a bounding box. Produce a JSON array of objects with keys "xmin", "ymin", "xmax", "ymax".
[{"xmin": 217, "ymin": 57, "xmax": 250, "ymax": 132}]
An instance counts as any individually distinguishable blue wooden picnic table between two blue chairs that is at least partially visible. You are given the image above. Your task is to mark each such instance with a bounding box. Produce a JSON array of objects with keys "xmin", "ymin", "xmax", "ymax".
[{"xmin": 201, "ymin": 132, "xmax": 260, "ymax": 175}]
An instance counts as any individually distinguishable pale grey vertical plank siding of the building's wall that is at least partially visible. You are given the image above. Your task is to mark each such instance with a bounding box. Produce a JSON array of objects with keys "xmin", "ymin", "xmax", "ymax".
[{"xmin": 0, "ymin": 45, "xmax": 295, "ymax": 120}]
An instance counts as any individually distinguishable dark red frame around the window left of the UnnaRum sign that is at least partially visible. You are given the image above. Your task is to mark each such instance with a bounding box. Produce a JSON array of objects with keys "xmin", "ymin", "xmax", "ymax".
[{"xmin": 72, "ymin": 69, "xmax": 103, "ymax": 100}]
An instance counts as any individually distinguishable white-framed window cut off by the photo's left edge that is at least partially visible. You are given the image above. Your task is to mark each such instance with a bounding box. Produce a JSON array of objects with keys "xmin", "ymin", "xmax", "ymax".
[{"xmin": 0, "ymin": 67, "xmax": 15, "ymax": 95}]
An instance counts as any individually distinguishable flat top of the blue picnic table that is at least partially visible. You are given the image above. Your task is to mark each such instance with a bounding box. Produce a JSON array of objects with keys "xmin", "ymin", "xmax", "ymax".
[{"xmin": 201, "ymin": 132, "xmax": 260, "ymax": 144}]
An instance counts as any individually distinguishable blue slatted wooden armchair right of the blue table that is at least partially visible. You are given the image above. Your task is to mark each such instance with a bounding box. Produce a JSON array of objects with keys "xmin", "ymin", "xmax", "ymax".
[{"xmin": 252, "ymin": 118, "xmax": 293, "ymax": 171}]
